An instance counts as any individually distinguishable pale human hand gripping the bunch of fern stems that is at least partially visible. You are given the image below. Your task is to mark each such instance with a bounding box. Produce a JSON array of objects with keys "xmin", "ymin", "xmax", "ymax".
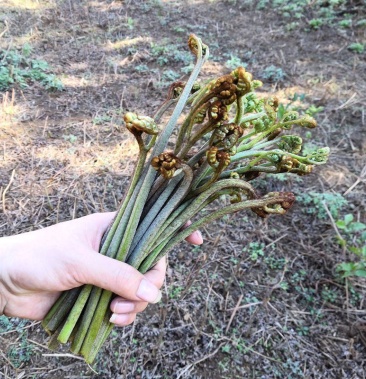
[{"xmin": 0, "ymin": 213, "xmax": 202, "ymax": 326}]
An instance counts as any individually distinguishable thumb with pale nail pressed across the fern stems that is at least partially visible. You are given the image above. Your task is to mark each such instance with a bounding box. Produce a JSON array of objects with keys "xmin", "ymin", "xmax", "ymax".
[{"xmin": 76, "ymin": 251, "xmax": 161, "ymax": 303}]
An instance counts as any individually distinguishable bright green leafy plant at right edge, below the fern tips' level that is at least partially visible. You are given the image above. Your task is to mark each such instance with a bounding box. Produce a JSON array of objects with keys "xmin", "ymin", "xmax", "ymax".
[{"xmin": 336, "ymin": 214, "xmax": 366, "ymax": 278}]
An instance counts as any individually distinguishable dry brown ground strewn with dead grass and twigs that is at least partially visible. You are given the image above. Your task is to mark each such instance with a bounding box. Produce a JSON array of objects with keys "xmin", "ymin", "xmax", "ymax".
[{"xmin": 0, "ymin": 0, "xmax": 366, "ymax": 379}]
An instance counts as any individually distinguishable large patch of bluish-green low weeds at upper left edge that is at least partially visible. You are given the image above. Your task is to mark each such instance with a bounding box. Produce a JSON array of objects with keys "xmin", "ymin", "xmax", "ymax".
[{"xmin": 0, "ymin": 44, "xmax": 63, "ymax": 91}]
